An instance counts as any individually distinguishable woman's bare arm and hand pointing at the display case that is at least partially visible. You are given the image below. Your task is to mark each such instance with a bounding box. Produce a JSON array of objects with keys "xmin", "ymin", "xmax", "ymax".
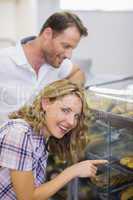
[{"xmin": 11, "ymin": 160, "xmax": 108, "ymax": 200}]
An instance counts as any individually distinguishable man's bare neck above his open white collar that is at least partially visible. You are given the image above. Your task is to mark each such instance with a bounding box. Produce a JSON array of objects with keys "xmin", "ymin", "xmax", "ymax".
[{"xmin": 23, "ymin": 39, "xmax": 45, "ymax": 74}]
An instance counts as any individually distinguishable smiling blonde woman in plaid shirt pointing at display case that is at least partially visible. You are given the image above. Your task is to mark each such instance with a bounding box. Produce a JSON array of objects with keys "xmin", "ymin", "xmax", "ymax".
[{"xmin": 0, "ymin": 80, "xmax": 107, "ymax": 200}]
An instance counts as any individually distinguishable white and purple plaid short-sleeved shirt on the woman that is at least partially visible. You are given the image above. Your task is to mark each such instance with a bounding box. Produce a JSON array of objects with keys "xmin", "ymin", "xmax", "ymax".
[{"xmin": 0, "ymin": 119, "xmax": 48, "ymax": 200}]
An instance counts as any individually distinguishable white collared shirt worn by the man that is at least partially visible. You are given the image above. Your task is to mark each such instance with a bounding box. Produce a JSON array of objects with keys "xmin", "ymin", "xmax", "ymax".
[{"xmin": 0, "ymin": 42, "xmax": 72, "ymax": 124}]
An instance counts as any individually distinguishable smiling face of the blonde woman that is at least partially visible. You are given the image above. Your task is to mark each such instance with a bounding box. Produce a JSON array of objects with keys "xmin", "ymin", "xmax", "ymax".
[{"xmin": 42, "ymin": 94, "xmax": 82, "ymax": 139}]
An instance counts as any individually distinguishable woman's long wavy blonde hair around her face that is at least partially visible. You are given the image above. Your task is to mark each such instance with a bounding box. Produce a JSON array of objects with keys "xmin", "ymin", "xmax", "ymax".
[{"xmin": 9, "ymin": 79, "xmax": 91, "ymax": 162}]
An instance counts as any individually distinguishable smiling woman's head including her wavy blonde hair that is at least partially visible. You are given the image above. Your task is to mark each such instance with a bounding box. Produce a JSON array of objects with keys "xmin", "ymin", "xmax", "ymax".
[{"xmin": 10, "ymin": 80, "xmax": 88, "ymax": 162}]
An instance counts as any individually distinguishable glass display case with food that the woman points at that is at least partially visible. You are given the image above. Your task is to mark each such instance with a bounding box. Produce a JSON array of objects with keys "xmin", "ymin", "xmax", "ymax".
[{"xmin": 75, "ymin": 78, "xmax": 133, "ymax": 200}]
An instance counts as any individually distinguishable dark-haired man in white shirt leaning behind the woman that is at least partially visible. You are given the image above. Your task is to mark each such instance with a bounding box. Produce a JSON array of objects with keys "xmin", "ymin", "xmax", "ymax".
[{"xmin": 0, "ymin": 12, "xmax": 87, "ymax": 123}]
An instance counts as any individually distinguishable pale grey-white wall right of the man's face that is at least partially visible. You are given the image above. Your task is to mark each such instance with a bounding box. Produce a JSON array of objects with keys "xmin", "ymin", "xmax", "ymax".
[{"xmin": 74, "ymin": 11, "xmax": 133, "ymax": 75}]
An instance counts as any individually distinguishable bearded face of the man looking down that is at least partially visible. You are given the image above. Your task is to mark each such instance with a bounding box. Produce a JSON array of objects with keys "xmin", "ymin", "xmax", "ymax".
[{"xmin": 42, "ymin": 27, "xmax": 81, "ymax": 68}]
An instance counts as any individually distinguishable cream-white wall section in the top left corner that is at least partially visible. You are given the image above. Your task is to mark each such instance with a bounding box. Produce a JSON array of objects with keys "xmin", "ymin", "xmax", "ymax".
[{"xmin": 0, "ymin": 0, "xmax": 38, "ymax": 44}]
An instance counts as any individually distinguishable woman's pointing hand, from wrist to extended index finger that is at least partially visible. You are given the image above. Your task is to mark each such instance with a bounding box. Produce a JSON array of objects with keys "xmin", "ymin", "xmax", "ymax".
[{"xmin": 69, "ymin": 160, "xmax": 108, "ymax": 178}]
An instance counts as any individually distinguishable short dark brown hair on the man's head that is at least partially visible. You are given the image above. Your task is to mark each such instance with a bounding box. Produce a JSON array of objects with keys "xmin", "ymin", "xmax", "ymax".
[{"xmin": 39, "ymin": 12, "xmax": 88, "ymax": 36}]
